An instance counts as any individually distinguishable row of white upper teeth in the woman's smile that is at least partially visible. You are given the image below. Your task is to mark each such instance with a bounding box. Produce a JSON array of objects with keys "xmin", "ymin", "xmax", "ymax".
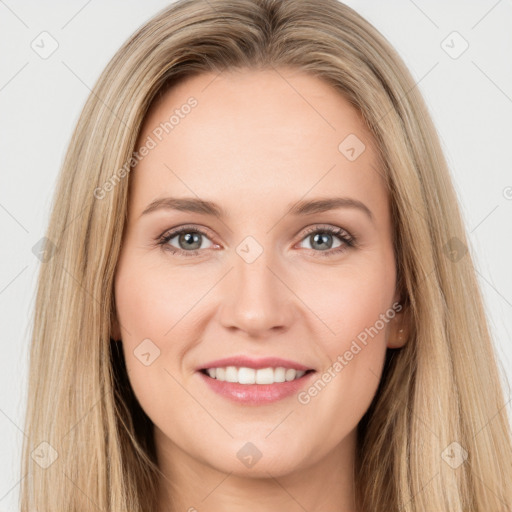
[{"xmin": 206, "ymin": 366, "xmax": 306, "ymax": 384}]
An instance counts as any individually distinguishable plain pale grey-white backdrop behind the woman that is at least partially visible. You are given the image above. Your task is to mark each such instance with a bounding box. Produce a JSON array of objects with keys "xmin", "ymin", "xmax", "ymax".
[{"xmin": 0, "ymin": 0, "xmax": 512, "ymax": 512}]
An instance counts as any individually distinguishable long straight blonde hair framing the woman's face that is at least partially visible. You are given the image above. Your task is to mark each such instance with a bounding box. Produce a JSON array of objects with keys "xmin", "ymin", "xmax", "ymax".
[{"xmin": 20, "ymin": 0, "xmax": 512, "ymax": 512}]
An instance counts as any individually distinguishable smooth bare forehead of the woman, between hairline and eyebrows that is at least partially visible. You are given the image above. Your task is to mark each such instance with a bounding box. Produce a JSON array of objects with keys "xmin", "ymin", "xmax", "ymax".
[{"xmin": 131, "ymin": 70, "xmax": 387, "ymax": 218}]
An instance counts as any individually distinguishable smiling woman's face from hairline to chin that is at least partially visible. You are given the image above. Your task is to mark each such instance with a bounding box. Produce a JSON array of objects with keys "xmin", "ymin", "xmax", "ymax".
[{"xmin": 114, "ymin": 70, "xmax": 406, "ymax": 476}]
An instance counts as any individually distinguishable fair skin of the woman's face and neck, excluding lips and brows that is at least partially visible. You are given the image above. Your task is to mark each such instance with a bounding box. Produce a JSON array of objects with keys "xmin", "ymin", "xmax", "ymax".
[{"xmin": 113, "ymin": 69, "xmax": 407, "ymax": 512}]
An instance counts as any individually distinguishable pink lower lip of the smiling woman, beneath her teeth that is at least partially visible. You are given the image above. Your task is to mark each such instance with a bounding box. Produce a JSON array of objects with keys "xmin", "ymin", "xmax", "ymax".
[{"xmin": 198, "ymin": 372, "xmax": 316, "ymax": 405}]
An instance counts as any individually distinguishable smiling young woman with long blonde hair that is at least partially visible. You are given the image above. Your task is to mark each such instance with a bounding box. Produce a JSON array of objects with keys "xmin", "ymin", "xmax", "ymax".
[{"xmin": 21, "ymin": 0, "xmax": 512, "ymax": 512}]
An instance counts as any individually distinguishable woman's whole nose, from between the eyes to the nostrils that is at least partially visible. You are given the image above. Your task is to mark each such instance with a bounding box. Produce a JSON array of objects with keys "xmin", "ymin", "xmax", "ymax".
[{"xmin": 218, "ymin": 237, "xmax": 292, "ymax": 334}]
